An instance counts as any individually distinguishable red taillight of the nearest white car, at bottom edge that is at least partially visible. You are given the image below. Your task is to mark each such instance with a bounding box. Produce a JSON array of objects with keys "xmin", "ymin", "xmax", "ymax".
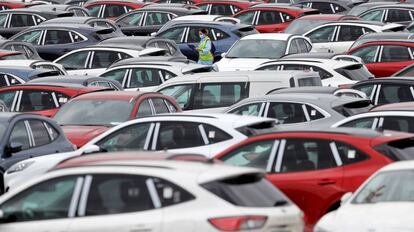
[{"xmin": 208, "ymin": 215, "xmax": 267, "ymax": 231}]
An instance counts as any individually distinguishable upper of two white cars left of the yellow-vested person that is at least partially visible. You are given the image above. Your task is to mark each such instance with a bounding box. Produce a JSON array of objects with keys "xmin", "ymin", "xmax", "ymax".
[{"xmin": 53, "ymin": 44, "xmax": 167, "ymax": 76}]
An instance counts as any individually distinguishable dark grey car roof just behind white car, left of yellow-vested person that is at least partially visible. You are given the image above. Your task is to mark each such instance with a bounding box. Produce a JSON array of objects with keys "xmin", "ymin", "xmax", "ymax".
[{"xmin": 99, "ymin": 36, "xmax": 184, "ymax": 57}]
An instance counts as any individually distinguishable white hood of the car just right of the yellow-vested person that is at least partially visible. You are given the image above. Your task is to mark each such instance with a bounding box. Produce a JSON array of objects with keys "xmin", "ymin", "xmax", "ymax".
[{"xmin": 216, "ymin": 58, "xmax": 270, "ymax": 72}]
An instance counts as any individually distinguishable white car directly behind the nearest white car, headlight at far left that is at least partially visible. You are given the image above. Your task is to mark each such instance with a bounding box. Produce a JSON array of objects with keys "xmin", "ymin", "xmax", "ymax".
[{"xmin": 4, "ymin": 113, "xmax": 275, "ymax": 189}]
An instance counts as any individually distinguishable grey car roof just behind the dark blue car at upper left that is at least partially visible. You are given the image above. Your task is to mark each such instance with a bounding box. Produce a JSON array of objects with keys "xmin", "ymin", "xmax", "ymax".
[{"xmin": 42, "ymin": 16, "xmax": 125, "ymax": 37}]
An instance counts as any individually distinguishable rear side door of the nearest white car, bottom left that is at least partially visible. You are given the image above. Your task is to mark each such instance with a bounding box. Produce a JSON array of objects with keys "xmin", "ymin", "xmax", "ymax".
[{"xmin": 68, "ymin": 173, "xmax": 163, "ymax": 232}]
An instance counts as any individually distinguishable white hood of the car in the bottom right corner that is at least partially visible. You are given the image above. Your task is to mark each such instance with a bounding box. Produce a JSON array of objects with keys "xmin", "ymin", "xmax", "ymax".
[{"xmin": 326, "ymin": 202, "xmax": 414, "ymax": 232}]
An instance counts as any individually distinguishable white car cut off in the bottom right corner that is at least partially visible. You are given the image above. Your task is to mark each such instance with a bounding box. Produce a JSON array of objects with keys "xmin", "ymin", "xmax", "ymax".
[{"xmin": 314, "ymin": 161, "xmax": 414, "ymax": 232}]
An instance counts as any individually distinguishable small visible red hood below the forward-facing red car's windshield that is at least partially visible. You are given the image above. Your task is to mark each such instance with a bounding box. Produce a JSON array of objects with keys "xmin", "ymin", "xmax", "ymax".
[{"xmin": 62, "ymin": 126, "xmax": 109, "ymax": 148}]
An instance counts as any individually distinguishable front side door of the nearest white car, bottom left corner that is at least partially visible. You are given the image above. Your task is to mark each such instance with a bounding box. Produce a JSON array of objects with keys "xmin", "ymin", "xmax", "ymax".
[{"xmin": 0, "ymin": 175, "xmax": 83, "ymax": 232}]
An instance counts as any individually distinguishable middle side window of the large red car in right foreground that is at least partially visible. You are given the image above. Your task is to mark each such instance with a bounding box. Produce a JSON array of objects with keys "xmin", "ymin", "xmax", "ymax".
[{"xmin": 280, "ymin": 139, "xmax": 337, "ymax": 172}]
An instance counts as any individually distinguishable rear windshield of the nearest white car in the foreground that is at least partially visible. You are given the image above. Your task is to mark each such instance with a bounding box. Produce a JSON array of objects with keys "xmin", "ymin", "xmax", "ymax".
[{"xmin": 201, "ymin": 174, "xmax": 289, "ymax": 207}]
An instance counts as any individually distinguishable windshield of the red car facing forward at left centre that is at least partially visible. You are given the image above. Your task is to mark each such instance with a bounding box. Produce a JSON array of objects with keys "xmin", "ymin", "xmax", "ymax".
[{"xmin": 54, "ymin": 100, "xmax": 133, "ymax": 126}]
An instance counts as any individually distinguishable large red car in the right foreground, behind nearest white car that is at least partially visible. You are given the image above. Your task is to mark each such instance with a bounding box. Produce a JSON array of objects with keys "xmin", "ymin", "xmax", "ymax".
[{"xmin": 216, "ymin": 128, "xmax": 414, "ymax": 230}]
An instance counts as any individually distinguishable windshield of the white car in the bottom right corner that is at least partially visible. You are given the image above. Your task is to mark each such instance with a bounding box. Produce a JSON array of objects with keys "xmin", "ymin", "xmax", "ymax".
[{"xmin": 352, "ymin": 170, "xmax": 414, "ymax": 204}]
